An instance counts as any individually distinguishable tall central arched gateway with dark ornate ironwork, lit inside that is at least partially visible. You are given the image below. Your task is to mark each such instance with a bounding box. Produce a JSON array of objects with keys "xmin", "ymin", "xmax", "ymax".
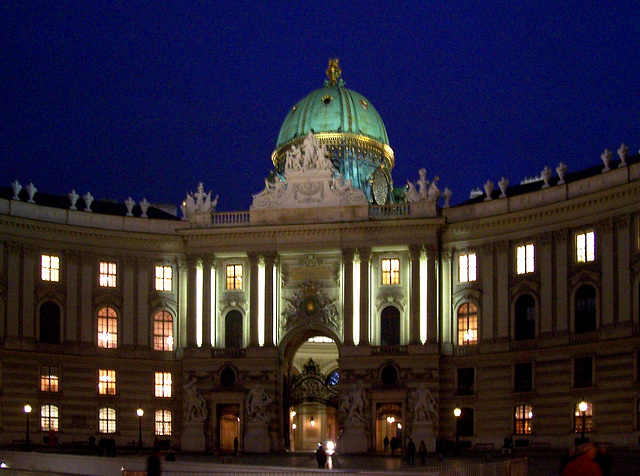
[{"xmin": 285, "ymin": 336, "xmax": 339, "ymax": 451}]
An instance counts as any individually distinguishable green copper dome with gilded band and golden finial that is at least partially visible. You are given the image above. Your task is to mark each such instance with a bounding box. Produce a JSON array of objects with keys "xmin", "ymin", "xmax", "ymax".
[{"xmin": 271, "ymin": 59, "xmax": 395, "ymax": 205}]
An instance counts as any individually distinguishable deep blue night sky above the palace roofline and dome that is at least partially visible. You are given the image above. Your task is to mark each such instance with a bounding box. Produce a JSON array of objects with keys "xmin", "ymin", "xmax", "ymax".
[{"xmin": 0, "ymin": 0, "xmax": 640, "ymax": 210}]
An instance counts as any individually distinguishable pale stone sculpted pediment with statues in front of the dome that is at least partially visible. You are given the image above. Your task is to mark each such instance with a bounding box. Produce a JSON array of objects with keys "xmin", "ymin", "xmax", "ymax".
[{"xmin": 251, "ymin": 132, "xmax": 369, "ymax": 210}]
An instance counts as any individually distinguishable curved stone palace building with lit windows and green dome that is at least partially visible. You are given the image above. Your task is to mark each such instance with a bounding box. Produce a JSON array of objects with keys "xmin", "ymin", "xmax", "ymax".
[{"xmin": 0, "ymin": 62, "xmax": 640, "ymax": 452}]
